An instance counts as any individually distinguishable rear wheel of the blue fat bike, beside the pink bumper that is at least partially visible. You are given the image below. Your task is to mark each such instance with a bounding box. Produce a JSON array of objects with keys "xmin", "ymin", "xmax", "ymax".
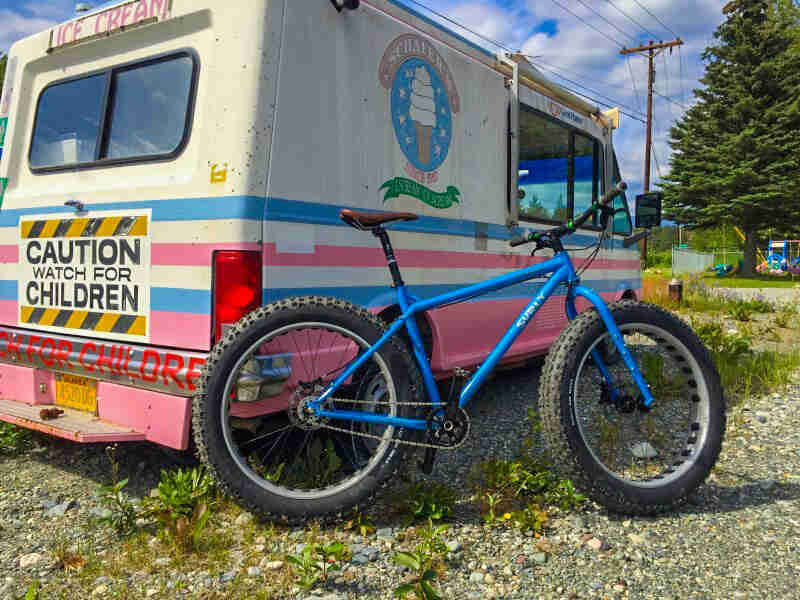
[{"xmin": 193, "ymin": 297, "xmax": 421, "ymax": 522}]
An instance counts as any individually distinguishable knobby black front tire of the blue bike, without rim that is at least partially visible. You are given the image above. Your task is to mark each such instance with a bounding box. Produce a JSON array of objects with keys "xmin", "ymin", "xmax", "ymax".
[{"xmin": 539, "ymin": 300, "xmax": 725, "ymax": 515}]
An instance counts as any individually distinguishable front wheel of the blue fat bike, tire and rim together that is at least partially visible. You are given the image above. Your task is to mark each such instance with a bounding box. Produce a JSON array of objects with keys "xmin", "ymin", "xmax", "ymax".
[{"xmin": 539, "ymin": 301, "xmax": 725, "ymax": 514}]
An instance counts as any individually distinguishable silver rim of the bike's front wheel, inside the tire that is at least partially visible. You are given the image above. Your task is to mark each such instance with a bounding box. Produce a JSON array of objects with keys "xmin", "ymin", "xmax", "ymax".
[{"xmin": 572, "ymin": 323, "xmax": 710, "ymax": 488}]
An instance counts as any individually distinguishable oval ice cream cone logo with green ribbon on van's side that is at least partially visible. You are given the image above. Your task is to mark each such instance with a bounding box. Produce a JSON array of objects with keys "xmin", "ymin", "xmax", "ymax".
[{"xmin": 379, "ymin": 34, "xmax": 461, "ymax": 209}]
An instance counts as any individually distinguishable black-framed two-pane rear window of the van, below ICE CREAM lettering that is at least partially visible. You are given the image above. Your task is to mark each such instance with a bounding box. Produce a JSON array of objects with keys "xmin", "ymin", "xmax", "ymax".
[{"xmin": 30, "ymin": 53, "xmax": 196, "ymax": 171}]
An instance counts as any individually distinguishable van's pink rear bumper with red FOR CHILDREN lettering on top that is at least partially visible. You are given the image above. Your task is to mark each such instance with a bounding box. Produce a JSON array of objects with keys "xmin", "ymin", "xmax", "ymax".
[{"xmin": 0, "ymin": 327, "xmax": 207, "ymax": 450}]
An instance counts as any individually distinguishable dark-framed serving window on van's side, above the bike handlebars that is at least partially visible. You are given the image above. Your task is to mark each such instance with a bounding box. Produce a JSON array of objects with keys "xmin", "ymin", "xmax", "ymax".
[{"xmin": 519, "ymin": 105, "xmax": 603, "ymax": 223}]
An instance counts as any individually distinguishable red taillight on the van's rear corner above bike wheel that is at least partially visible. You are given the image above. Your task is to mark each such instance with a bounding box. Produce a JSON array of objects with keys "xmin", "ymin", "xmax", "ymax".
[{"xmin": 214, "ymin": 250, "xmax": 262, "ymax": 342}]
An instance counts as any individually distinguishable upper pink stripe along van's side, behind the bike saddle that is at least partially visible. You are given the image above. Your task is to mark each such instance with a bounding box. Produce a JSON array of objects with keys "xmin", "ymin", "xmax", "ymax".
[{"xmin": 264, "ymin": 243, "xmax": 639, "ymax": 270}]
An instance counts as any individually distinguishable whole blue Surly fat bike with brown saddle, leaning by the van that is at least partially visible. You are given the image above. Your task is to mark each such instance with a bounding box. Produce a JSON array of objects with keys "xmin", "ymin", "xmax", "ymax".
[{"xmin": 193, "ymin": 184, "xmax": 725, "ymax": 521}]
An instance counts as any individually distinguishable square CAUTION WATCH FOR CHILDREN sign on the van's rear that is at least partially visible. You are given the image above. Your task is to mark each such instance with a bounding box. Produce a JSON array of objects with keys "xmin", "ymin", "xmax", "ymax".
[{"xmin": 19, "ymin": 211, "xmax": 150, "ymax": 341}]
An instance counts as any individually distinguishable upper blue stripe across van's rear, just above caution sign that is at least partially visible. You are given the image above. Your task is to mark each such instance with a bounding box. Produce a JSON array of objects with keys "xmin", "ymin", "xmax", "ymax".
[{"xmin": 0, "ymin": 196, "xmax": 265, "ymax": 227}]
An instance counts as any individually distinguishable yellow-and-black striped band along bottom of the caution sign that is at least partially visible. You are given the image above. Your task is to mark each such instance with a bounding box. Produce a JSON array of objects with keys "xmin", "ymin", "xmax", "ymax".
[{"xmin": 20, "ymin": 306, "xmax": 147, "ymax": 336}]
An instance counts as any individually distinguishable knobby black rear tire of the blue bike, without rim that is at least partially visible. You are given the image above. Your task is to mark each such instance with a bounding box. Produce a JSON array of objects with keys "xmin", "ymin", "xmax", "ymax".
[{"xmin": 192, "ymin": 296, "xmax": 422, "ymax": 523}]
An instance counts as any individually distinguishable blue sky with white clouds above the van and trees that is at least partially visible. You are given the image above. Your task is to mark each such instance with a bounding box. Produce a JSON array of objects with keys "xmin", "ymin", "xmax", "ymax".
[{"xmin": 0, "ymin": 0, "xmax": 728, "ymax": 203}]
